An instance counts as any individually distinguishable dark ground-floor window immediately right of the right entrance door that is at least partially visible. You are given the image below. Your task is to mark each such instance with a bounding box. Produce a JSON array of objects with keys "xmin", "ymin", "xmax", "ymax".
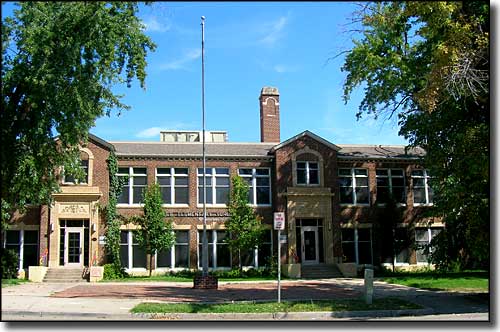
[{"xmin": 341, "ymin": 228, "xmax": 373, "ymax": 264}]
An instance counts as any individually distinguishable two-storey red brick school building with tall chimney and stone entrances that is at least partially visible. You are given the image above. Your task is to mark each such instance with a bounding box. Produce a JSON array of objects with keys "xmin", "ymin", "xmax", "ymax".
[{"xmin": 3, "ymin": 87, "xmax": 443, "ymax": 277}]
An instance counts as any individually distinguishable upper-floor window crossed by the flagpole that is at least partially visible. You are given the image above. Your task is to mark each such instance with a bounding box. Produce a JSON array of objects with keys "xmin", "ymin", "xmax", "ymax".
[{"xmin": 198, "ymin": 168, "xmax": 229, "ymax": 205}]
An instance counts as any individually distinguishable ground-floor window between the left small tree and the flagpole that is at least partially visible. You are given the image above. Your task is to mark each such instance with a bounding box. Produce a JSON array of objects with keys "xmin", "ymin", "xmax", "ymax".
[{"xmin": 156, "ymin": 231, "xmax": 189, "ymax": 268}]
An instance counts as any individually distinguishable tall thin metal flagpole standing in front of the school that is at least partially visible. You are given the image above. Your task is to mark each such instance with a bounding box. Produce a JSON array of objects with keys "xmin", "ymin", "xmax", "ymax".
[{"xmin": 201, "ymin": 16, "xmax": 208, "ymax": 276}]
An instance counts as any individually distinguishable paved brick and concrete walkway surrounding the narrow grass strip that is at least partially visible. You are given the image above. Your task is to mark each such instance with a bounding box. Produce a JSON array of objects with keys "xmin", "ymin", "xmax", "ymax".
[{"xmin": 2, "ymin": 279, "xmax": 489, "ymax": 321}]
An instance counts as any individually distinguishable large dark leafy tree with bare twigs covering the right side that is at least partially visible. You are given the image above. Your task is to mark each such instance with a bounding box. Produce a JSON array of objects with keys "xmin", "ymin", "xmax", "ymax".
[{"xmin": 342, "ymin": 1, "xmax": 489, "ymax": 268}]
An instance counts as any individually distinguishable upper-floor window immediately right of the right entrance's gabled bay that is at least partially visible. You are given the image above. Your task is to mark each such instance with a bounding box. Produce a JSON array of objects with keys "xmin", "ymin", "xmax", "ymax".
[{"xmin": 338, "ymin": 168, "xmax": 370, "ymax": 205}]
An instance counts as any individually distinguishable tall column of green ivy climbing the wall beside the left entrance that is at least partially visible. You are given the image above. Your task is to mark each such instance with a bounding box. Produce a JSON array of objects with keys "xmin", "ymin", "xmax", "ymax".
[{"xmin": 105, "ymin": 151, "xmax": 127, "ymax": 270}]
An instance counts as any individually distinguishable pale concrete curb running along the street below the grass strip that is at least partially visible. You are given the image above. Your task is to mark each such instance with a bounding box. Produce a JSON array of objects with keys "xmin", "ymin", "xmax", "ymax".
[{"xmin": 2, "ymin": 308, "xmax": 434, "ymax": 321}]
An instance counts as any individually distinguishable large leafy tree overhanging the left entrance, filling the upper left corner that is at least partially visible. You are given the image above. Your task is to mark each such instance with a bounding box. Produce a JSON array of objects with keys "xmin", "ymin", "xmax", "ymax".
[{"xmin": 0, "ymin": 1, "xmax": 155, "ymax": 227}]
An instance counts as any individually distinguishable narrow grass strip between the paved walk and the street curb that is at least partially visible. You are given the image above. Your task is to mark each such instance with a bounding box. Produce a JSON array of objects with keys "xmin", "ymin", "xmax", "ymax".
[{"xmin": 131, "ymin": 298, "xmax": 422, "ymax": 313}]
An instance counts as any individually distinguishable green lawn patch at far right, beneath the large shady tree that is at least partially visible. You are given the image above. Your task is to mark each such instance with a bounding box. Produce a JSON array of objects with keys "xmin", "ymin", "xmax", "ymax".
[{"xmin": 380, "ymin": 271, "xmax": 489, "ymax": 292}]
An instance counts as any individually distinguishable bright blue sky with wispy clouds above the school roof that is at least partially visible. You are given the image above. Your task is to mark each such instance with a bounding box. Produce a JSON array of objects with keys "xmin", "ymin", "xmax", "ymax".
[{"xmin": 2, "ymin": 2, "xmax": 418, "ymax": 144}]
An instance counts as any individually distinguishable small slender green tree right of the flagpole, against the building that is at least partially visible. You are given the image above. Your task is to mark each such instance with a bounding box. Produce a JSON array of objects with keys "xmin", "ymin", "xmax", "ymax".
[{"xmin": 225, "ymin": 176, "xmax": 264, "ymax": 271}]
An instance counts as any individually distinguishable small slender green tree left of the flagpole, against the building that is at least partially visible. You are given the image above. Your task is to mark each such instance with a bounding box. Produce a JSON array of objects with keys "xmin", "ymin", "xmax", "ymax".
[{"xmin": 132, "ymin": 183, "xmax": 175, "ymax": 276}]
